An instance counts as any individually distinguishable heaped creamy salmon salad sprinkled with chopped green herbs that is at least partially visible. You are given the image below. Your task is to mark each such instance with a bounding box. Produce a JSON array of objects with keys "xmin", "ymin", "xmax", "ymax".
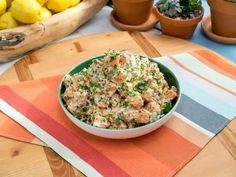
[{"xmin": 62, "ymin": 50, "xmax": 178, "ymax": 129}]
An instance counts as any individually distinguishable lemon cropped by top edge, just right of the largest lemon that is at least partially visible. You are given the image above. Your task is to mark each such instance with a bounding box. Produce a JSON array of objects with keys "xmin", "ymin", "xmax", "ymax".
[{"xmin": 47, "ymin": 0, "xmax": 71, "ymax": 12}]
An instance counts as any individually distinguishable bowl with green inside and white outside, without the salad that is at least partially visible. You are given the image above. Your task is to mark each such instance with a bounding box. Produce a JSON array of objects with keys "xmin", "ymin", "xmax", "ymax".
[{"xmin": 58, "ymin": 55, "xmax": 181, "ymax": 139}]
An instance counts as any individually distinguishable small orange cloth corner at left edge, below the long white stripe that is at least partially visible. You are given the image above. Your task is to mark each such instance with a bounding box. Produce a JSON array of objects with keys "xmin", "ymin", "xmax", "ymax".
[{"xmin": 0, "ymin": 112, "xmax": 35, "ymax": 143}]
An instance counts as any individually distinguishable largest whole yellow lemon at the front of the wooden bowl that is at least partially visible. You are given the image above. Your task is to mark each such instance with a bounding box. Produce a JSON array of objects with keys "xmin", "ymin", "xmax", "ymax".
[{"xmin": 10, "ymin": 0, "xmax": 42, "ymax": 24}]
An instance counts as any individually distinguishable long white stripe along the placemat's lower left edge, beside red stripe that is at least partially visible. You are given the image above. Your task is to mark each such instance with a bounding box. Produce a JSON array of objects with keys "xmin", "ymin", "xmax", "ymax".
[{"xmin": 0, "ymin": 98, "xmax": 102, "ymax": 177}]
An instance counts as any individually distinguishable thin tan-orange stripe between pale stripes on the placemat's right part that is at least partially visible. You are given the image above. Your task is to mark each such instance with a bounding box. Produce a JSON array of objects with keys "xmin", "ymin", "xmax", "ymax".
[{"xmin": 168, "ymin": 56, "xmax": 236, "ymax": 96}]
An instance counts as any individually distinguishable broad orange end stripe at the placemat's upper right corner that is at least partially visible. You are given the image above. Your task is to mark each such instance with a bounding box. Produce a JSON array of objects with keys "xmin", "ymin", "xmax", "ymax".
[{"xmin": 190, "ymin": 50, "xmax": 236, "ymax": 79}]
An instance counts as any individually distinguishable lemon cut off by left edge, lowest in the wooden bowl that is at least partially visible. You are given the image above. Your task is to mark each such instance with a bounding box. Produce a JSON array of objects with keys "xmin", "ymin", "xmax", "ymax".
[{"xmin": 0, "ymin": 12, "xmax": 20, "ymax": 30}]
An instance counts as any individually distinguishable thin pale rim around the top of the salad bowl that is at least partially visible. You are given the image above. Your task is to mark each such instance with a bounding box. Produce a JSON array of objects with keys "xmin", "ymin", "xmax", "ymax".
[{"xmin": 57, "ymin": 54, "xmax": 182, "ymax": 132}]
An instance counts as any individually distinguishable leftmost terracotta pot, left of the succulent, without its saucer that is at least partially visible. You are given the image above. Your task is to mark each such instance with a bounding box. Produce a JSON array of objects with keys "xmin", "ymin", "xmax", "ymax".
[{"xmin": 112, "ymin": 0, "xmax": 153, "ymax": 25}]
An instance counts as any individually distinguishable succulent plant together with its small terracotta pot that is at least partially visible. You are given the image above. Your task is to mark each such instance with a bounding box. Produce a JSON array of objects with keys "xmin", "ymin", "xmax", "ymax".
[{"xmin": 156, "ymin": 0, "xmax": 204, "ymax": 39}]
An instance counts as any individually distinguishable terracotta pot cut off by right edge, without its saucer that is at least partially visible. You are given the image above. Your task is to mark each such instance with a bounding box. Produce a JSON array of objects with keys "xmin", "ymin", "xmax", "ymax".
[{"xmin": 208, "ymin": 0, "xmax": 236, "ymax": 38}]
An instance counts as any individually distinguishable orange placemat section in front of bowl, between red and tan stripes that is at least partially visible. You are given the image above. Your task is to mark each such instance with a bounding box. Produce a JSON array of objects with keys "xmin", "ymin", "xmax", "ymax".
[{"xmin": 82, "ymin": 126, "xmax": 201, "ymax": 177}]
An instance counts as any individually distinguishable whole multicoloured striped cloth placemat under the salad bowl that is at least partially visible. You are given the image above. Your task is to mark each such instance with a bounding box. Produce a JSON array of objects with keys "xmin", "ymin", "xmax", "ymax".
[{"xmin": 0, "ymin": 50, "xmax": 236, "ymax": 177}]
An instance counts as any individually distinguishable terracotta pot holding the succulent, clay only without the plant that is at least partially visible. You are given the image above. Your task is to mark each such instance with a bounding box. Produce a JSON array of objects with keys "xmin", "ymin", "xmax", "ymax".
[{"xmin": 157, "ymin": 8, "xmax": 204, "ymax": 39}]
